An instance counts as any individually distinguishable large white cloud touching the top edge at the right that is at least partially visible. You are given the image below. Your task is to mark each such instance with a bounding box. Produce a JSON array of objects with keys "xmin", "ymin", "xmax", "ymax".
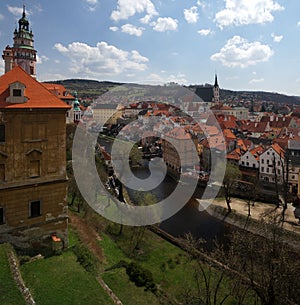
[{"xmin": 215, "ymin": 0, "xmax": 284, "ymax": 28}]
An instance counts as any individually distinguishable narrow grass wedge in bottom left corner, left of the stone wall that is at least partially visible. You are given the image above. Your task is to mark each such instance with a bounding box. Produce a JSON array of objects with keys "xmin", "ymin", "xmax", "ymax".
[{"xmin": 0, "ymin": 244, "xmax": 26, "ymax": 305}]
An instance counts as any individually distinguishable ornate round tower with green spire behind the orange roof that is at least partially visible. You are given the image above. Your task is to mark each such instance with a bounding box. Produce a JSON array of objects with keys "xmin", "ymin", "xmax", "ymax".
[{"xmin": 2, "ymin": 6, "xmax": 37, "ymax": 77}]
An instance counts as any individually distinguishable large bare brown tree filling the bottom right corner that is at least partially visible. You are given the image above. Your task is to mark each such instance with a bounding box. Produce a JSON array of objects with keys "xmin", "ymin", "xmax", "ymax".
[{"xmin": 227, "ymin": 211, "xmax": 300, "ymax": 305}]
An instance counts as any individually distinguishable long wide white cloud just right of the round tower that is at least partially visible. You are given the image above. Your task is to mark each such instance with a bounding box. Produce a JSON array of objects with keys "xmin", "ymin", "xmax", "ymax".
[{"xmin": 54, "ymin": 41, "xmax": 148, "ymax": 76}]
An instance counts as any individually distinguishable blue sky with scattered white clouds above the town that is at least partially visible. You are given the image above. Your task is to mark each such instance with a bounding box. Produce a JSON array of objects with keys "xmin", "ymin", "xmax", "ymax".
[{"xmin": 0, "ymin": 0, "xmax": 300, "ymax": 95}]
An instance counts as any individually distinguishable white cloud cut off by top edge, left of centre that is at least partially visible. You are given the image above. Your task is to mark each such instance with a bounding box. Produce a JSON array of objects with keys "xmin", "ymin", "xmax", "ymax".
[{"xmin": 110, "ymin": 0, "xmax": 158, "ymax": 22}]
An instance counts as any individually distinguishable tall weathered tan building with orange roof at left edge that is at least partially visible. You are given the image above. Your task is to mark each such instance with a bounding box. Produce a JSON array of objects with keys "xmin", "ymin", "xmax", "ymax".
[{"xmin": 0, "ymin": 66, "xmax": 70, "ymax": 248}]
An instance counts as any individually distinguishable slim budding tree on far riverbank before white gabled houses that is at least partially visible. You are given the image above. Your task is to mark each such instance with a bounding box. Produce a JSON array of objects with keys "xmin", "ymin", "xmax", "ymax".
[{"xmin": 222, "ymin": 162, "xmax": 242, "ymax": 213}]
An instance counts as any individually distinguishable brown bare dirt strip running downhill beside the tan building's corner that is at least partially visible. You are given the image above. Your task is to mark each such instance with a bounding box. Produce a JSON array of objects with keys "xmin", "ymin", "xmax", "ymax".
[{"xmin": 69, "ymin": 211, "xmax": 105, "ymax": 262}]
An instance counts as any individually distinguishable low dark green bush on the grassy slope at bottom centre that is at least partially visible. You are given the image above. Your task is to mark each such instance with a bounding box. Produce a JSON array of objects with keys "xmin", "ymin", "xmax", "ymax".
[{"xmin": 126, "ymin": 262, "xmax": 157, "ymax": 293}]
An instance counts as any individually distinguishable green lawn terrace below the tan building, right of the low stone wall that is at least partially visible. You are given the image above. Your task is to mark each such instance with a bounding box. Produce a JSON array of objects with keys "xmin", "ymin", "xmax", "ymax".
[{"xmin": 21, "ymin": 251, "xmax": 113, "ymax": 305}]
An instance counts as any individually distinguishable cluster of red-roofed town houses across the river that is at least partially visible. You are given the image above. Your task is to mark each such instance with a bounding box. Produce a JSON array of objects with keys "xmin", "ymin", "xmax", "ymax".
[{"xmin": 95, "ymin": 97, "xmax": 300, "ymax": 193}]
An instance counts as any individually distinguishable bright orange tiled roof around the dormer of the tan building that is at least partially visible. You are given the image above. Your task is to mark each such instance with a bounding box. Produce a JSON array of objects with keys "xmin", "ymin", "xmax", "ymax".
[{"xmin": 0, "ymin": 66, "xmax": 70, "ymax": 110}]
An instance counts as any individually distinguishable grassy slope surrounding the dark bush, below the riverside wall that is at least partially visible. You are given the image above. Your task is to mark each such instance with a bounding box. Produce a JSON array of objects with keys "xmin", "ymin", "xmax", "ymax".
[{"xmin": 100, "ymin": 228, "xmax": 240, "ymax": 305}]
